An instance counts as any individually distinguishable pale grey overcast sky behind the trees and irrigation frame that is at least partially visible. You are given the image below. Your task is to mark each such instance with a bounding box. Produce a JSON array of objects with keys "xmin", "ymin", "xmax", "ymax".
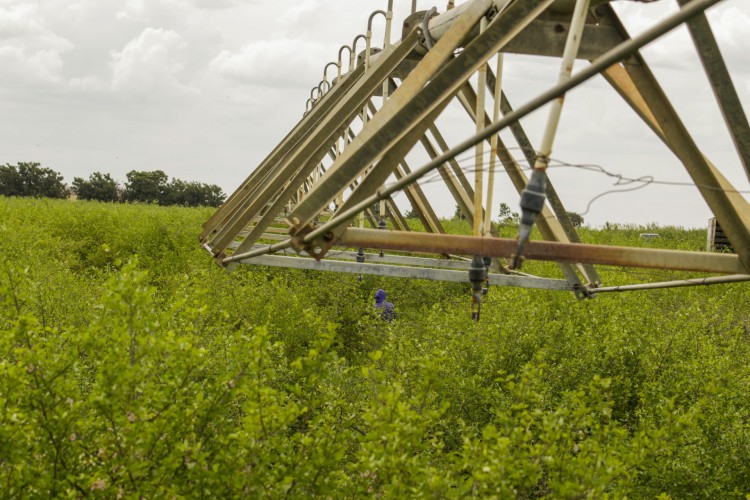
[{"xmin": 0, "ymin": 0, "xmax": 750, "ymax": 227}]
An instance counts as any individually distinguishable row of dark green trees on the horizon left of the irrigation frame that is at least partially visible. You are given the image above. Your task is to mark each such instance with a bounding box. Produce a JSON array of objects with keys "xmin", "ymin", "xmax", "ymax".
[{"xmin": 0, "ymin": 162, "xmax": 226, "ymax": 207}]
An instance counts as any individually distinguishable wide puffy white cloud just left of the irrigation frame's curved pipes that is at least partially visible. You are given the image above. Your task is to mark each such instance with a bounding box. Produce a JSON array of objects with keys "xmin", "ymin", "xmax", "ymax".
[{"xmin": 211, "ymin": 39, "xmax": 331, "ymax": 88}]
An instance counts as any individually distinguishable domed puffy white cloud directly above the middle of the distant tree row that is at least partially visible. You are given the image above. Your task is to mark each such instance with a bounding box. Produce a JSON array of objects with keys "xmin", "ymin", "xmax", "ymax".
[{"xmin": 111, "ymin": 28, "xmax": 193, "ymax": 95}]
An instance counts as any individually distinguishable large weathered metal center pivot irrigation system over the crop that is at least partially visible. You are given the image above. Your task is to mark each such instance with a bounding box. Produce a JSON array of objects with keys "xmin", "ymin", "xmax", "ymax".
[{"xmin": 200, "ymin": 0, "xmax": 750, "ymax": 319}]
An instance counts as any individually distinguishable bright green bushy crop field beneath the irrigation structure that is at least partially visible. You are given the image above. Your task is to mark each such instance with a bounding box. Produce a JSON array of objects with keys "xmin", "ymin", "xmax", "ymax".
[{"xmin": 0, "ymin": 198, "xmax": 750, "ymax": 498}]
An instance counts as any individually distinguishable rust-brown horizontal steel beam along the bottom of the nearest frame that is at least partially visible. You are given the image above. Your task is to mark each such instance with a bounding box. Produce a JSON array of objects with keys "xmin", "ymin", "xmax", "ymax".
[{"xmin": 338, "ymin": 228, "xmax": 746, "ymax": 274}]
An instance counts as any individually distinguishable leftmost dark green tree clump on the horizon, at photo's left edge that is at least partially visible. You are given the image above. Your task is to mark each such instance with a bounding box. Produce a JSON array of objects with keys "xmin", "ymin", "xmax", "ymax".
[{"xmin": 0, "ymin": 162, "xmax": 68, "ymax": 198}]
